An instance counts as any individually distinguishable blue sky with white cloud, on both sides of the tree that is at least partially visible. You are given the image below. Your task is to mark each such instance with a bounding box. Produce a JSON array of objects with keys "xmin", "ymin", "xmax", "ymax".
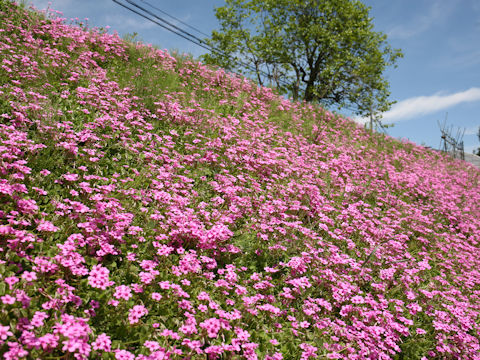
[{"xmin": 29, "ymin": 0, "xmax": 480, "ymax": 152}]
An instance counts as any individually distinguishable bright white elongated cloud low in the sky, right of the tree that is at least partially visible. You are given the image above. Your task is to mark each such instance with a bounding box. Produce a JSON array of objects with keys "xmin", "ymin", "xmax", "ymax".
[{"xmin": 383, "ymin": 87, "xmax": 480, "ymax": 122}]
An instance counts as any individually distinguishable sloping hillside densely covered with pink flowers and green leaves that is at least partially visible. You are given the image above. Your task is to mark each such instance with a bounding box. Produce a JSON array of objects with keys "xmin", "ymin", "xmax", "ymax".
[{"xmin": 0, "ymin": 0, "xmax": 480, "ymax": 360}]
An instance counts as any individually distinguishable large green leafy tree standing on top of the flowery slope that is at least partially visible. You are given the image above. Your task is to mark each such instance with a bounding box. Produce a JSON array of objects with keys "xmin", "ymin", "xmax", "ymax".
[{"xmin": 203, "ymin": 0, "xmax": 402, "ymax": 116}]
